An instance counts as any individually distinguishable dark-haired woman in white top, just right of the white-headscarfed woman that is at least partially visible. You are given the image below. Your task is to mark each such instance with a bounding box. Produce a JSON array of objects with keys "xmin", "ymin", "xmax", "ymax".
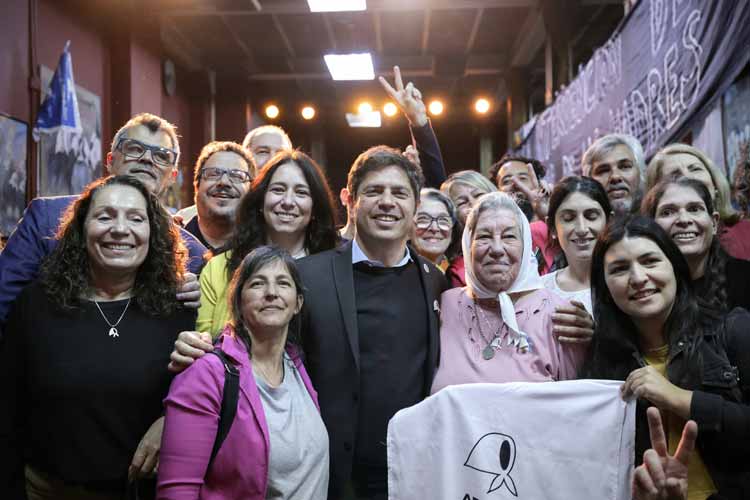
[{"xmin": 542, "ymin": 176, "xmax": 612, "ymax": 314}]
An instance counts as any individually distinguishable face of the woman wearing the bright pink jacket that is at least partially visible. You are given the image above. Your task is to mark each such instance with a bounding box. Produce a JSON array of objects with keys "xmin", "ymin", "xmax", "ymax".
[{"xmin": 241, "ymin": 260, "xmax": 302, "ymax": 332}]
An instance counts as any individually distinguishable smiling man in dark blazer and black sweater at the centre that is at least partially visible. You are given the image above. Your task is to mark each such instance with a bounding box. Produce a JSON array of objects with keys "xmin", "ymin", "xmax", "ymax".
[{"xmin": 171, "ymin": 146, "xmax": 448, "ymax": 500}]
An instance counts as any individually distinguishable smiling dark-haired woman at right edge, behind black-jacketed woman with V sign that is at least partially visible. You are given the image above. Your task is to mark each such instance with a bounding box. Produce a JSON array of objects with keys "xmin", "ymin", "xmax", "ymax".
[{"xmin": 641, "ymin": 178, "xmax": 750, "ymax": 312}]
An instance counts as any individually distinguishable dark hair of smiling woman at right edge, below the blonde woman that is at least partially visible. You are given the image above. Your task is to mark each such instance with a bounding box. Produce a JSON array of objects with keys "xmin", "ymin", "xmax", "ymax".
[{"xmin": 641, "ymin": 177, "xmax": 729, "ymax": 312}]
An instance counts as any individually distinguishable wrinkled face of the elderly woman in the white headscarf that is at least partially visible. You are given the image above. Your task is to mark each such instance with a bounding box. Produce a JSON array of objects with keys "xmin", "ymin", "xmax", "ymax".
[{"xmin": 471, "ymin": 209, "xmax": 523, "ymax": 292}]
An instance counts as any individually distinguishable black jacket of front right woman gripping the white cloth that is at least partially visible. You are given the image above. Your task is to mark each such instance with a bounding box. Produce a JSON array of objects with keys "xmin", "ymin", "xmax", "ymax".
[{"xmin": 633, "ymin": 308, "xmax": 750, "ymax": 500}]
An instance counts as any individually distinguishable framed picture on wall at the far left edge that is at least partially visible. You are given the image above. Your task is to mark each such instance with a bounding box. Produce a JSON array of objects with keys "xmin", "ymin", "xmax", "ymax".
[{"xmin": 0, "ymin": 114, "xmax": 29, "ymax": 237}]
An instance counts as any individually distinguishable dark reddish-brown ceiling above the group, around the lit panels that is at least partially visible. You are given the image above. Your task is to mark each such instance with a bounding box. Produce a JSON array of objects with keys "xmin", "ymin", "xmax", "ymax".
[{"xmin": 160, "ymin": 0, "xmax": 623, "ymax": 125}]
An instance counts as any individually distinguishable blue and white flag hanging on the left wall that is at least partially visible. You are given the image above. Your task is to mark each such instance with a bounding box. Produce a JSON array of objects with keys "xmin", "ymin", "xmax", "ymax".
[{"xmin": 33, "ymin": 41, "xmax": 83, "ymax": 153}]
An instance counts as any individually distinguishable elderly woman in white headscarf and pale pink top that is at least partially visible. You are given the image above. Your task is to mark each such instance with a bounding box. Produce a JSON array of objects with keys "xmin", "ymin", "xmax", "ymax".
[{"xmin": 432, "ymin": 192, "xmax": 584, "ymax": 393}]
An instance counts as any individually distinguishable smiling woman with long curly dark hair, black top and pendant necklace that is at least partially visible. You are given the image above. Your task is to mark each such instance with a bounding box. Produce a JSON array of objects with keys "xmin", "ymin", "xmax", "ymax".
[{"xmin": 0, "ymin": 176, "xmax": 195, "ymax": 499}]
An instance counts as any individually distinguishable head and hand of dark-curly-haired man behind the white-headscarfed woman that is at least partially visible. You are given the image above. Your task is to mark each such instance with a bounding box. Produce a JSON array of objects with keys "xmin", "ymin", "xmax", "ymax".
[{"xmin": 489, "ymin": 155, "xmax": 549, "ymax": 222}]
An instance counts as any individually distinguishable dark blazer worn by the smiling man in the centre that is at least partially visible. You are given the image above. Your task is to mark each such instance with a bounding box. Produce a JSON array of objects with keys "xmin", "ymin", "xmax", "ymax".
[{"xmin": 298, "ymin": 242, "xmax": 448, "ymax": 500}]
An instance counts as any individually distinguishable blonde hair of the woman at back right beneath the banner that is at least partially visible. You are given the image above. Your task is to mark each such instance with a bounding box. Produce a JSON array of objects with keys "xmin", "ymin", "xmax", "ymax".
[{"xmin": 646, "ymin": 143, "xmax": 739, "ymax": 226}]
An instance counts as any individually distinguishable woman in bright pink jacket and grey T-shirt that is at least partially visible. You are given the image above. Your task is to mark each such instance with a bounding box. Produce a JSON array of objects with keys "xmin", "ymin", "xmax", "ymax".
[{"xmin": 157, "ymin": 247, "xmax": 328, "ymax": 500}]
